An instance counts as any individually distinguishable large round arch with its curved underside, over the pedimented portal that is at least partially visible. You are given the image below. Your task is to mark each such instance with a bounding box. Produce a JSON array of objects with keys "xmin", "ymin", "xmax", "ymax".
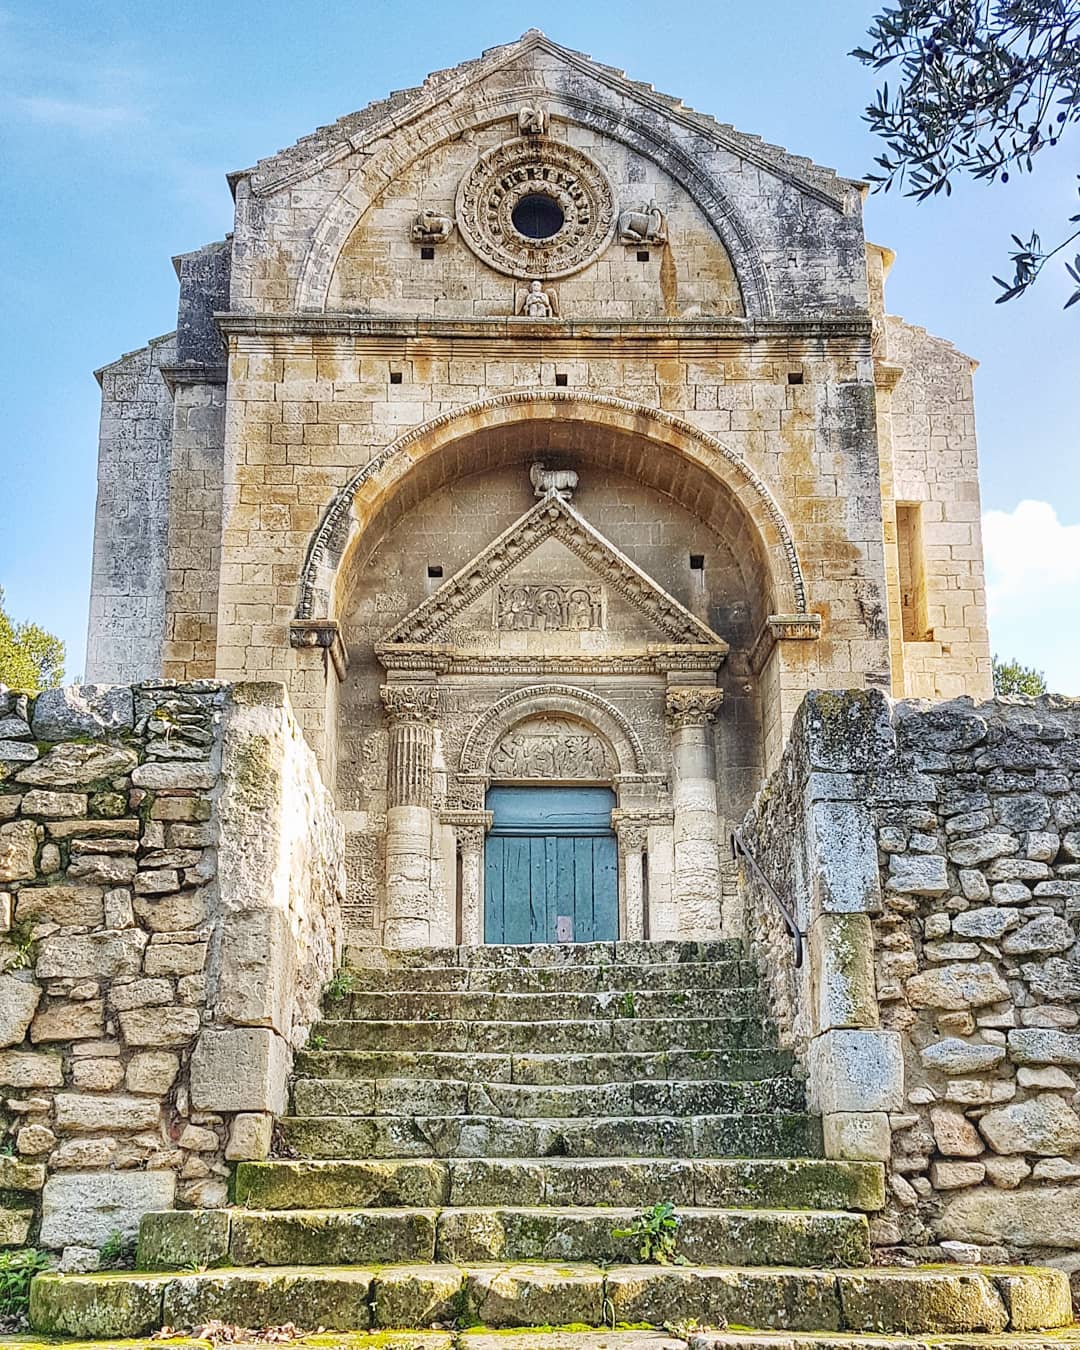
[{"xmin": 296, "ymin": 389, "xmax": 806, "ymax": 621}]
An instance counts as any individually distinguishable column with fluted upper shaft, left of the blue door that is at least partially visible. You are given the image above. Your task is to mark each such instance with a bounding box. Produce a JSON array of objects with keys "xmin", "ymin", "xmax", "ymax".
[{"xmin": 379, "ymin": 684, "xmax": 439, "ymax": 946}]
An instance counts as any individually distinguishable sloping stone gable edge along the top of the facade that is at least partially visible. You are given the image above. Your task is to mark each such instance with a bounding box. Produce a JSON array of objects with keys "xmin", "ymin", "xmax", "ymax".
[{"xmin": 230, "ymin": 28, "xmax": 853, "ymax": 207}]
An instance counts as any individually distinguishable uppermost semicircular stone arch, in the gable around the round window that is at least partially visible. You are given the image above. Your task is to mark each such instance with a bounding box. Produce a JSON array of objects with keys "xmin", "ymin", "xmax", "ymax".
[{"xmin": 296, "ymin": 84, "xmax": 775, "ymax": 319}]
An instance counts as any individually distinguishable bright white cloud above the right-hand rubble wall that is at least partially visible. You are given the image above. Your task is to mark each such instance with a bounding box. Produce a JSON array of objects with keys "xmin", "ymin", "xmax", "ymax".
[{"xmin": 983, "ymin": 500, "xmax": 1080, "ymax": 694}]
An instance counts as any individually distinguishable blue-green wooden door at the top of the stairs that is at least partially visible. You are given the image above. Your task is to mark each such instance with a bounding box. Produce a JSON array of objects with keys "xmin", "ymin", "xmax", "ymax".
[{"xmin": 483, "ymin": 787, "xmax": 618, "ymax": 942}]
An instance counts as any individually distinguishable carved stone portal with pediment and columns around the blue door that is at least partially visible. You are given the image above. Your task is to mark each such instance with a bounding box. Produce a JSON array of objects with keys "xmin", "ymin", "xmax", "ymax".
[{"xmin": 375, "ymin": 464, "xmax": 728, "ymax": 946}]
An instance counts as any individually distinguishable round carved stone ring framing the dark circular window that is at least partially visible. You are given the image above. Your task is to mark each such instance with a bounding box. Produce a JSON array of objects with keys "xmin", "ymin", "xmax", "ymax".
[{"xmin": 455, "ymin": 134, "xmax": 617, "ymax": 281}]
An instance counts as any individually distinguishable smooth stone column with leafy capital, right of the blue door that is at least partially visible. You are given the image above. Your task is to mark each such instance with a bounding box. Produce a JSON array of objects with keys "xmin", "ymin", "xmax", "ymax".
[{"xmin": 667, "ymin": 684, "xmax": 724, "ymax": 938}]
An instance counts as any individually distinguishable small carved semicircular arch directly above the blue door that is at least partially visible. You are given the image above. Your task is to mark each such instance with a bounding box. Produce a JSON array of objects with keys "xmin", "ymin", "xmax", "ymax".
[{"xmin": 459, "ymin": 684, "xmax": 647, "ymax": 778}]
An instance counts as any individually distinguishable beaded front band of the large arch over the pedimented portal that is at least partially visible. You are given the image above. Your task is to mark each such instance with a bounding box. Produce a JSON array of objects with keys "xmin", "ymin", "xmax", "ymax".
[{"xmin": 296, "ymin": 389, "xmax": 806, "ymax": 623}]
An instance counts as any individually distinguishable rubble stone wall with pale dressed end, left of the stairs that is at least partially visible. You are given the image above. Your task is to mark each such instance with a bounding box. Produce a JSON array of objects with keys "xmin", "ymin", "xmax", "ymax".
[{"xmin": 0, "ymin": 680, "xmax": 343, "ymax": 1247}]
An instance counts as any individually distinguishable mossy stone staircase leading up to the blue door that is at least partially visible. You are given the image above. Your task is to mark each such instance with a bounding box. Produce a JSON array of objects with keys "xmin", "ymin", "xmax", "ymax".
[{"xmin": 31, "ymin": 942, "xmax": 1080, "ymax": 1350}]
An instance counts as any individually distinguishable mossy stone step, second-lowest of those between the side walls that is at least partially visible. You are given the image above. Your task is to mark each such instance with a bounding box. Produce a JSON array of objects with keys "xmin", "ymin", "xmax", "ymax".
[{"xmin": 293, "ymin": 1076, "xmax": 806, "ymax": 1119}]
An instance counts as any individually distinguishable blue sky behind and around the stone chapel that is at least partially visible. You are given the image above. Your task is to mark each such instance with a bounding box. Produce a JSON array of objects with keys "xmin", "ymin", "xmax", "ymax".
[{"xmin": 0, "ymin": 0, "xmax": 1080, "ymax": 694}]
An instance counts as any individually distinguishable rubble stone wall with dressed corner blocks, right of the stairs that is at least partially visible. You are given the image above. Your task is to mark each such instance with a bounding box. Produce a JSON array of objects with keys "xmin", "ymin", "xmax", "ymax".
[{"xmin": 744, "ymin": 693, "xmax": 1080, "ymax": 1269}]
